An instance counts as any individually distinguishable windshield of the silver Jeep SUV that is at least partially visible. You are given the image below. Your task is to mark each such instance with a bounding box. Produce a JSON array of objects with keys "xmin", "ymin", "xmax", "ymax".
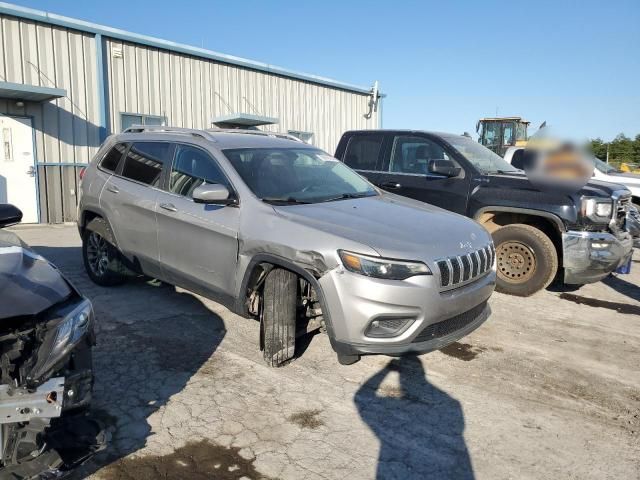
[{"xmin": 224, "ymin": 148, "xmax": 378, "ymax": 205}]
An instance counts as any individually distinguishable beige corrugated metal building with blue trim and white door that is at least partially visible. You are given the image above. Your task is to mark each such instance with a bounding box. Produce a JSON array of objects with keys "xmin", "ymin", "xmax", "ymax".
[{"xmin": 0, "ymin": 2, "xmax": 381, "ymax": 223}]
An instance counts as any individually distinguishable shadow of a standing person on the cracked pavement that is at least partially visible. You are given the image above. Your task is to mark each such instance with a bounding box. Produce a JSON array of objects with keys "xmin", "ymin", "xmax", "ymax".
[{"xmin": 355, "ymin": 356, "xmax": 474, "ymax": 480}]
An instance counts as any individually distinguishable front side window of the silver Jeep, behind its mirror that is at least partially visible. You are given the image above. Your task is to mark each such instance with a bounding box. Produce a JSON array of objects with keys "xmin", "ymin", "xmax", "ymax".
[{"xmin": 169, "ymin": 145, "xmax": 229, "ymax": 198}]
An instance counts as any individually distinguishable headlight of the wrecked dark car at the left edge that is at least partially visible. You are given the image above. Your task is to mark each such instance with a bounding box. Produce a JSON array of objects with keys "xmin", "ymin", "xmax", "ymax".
[{"xmin": 30, "ymin": 299, "xmax": 93, "ymax": 379}]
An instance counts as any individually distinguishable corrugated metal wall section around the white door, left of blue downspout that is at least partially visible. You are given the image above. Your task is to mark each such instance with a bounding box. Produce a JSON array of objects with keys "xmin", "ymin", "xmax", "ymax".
[{"xmin": 0, "ymin": 16, "xmax": 100, "ymax": 223}]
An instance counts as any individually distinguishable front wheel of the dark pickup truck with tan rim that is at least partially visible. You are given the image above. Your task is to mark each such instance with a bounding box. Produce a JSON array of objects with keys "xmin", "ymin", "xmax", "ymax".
[{"xmin": 492, "ymin": 224, "xmax": 558, "ymax": 297}]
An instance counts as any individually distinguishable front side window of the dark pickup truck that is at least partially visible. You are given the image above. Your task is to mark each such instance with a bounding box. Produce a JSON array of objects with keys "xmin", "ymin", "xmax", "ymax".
[{"xmin": 389, "ymin": 135, "xmax": 452, "ymax": 175}]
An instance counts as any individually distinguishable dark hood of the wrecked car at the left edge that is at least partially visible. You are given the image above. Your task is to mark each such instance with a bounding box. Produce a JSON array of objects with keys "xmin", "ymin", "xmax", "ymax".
[{"xmin": 0, "ymin": 231, "xmax": 73, "ymax": 320}]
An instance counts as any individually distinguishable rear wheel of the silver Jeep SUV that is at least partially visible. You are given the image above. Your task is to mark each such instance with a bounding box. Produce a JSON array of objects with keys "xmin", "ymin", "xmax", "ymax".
[{"xmin": 82, "ymin": 217, "xmax": 127, "ymax": 287}]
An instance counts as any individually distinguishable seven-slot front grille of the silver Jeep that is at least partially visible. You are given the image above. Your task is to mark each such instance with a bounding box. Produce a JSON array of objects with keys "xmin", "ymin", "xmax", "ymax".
[{"xmin": 436, "ymin": 244, "xmax": 496, "ymax": 289}]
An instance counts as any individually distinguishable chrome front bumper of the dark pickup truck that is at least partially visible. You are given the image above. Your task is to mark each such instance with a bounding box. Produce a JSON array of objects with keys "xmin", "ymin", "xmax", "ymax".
[{"xmin": 562, "ymin": 231, "xmax": 633, "ymax": 284}]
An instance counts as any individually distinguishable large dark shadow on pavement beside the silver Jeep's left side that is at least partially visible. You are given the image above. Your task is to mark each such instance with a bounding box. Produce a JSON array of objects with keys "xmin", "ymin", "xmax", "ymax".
[{"xmin": 28, "ymin": 246, "xmax": 226, "ymax": 479}]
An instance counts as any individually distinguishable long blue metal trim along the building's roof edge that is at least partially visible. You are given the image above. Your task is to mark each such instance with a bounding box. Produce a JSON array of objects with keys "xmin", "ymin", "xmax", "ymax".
[{"xmin": 0, "ymin": 2, "xmax": 371, "ymax": 94}]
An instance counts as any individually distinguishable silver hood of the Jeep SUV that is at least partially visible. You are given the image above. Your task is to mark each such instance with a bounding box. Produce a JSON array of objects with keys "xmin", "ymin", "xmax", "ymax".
[{"xmin": 274, "ymin": 194, "xmax": 491, "ymax": 265}]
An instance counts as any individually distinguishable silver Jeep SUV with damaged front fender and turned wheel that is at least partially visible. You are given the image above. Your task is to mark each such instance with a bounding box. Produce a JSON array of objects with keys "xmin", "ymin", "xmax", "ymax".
[{"xmin": 78, "ymin": 127, "xmax": 496, "ymax": 366}]
